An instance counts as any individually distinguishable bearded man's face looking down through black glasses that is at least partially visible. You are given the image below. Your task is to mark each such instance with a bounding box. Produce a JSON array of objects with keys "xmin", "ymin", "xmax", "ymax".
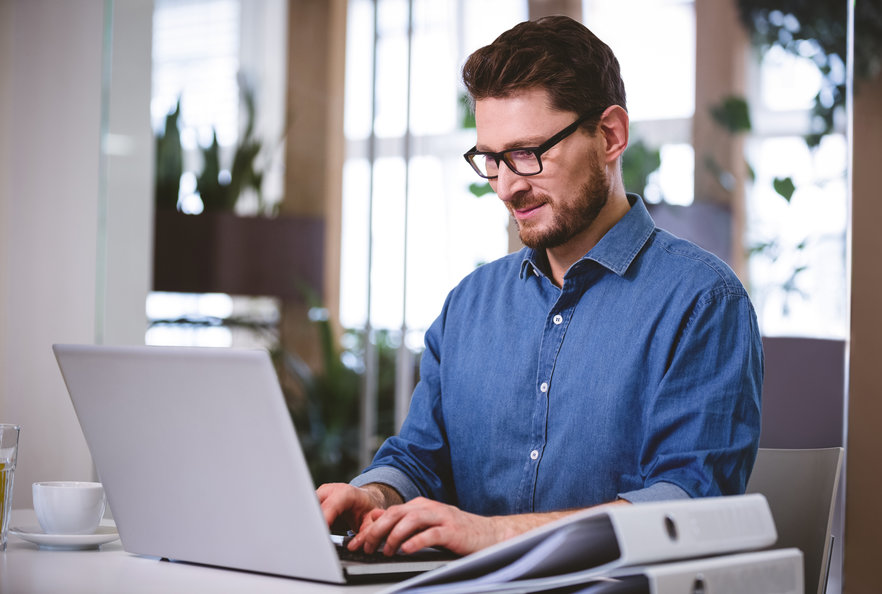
[{"xmin": 475, "ymin": 89, "xmax": 610, "ymax": 249}]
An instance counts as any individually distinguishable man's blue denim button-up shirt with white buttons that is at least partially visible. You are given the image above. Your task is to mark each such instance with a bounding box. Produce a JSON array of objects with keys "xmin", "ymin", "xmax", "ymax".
[{"xmin": 352, "ymin": 195, "xmax": 763, "ymax": 515}]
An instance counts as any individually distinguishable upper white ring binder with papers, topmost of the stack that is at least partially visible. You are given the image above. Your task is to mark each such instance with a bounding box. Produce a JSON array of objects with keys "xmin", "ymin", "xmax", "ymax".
[{"xmin": 387, "ymin": 494, "xmax": 777, "ymax": 594}]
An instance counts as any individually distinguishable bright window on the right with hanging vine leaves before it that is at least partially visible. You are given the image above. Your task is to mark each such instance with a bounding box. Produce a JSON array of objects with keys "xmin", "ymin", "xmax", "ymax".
[{"xmin": 747, "ymin": 47, "xmax": 848, "ymax": 338}]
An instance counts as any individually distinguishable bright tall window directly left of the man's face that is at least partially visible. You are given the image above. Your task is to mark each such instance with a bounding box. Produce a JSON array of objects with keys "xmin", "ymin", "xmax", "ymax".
[{"xmin": 340, "ymin": 0, "xmax": 527, "ymax": 332}]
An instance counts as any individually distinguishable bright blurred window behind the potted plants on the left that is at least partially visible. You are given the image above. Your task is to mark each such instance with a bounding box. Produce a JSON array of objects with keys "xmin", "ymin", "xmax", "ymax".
[{"xmin": 145, "ymin": 0, "xmax": 287, "ymax": 346}]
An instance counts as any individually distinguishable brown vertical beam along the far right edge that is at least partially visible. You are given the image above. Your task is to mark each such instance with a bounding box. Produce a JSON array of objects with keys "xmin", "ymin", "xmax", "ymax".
[{"xmin": 843, "ymin": 65, "xmax": 882, "ymax": 594}]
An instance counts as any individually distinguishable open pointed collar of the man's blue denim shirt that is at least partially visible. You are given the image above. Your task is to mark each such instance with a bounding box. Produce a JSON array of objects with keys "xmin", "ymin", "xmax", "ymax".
[{"xmin": 519, "ymin": 194, "xmax": 655, "ymax": 279}]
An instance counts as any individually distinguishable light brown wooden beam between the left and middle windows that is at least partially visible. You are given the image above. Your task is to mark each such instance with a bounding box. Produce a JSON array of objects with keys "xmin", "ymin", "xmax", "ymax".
[{"xmin": 280, "ymin": 0, "xmax": 346, "ymax": 365}]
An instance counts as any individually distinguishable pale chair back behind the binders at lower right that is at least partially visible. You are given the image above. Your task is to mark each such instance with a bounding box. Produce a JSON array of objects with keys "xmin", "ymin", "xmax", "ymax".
[{"xmin": 747, "ymin": 448, "xmax": 843, "ymax": 594}]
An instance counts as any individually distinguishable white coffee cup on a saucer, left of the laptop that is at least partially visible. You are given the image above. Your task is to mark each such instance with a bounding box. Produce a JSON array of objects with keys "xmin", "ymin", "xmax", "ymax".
[{"xmin": 33, "ymin": 481, "xmax": 105, "ymax": 534}]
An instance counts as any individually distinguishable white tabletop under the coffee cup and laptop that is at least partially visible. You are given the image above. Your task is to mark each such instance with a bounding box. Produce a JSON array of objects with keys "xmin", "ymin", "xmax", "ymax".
[{"xmin": 0, "ymin": 509, "xmax": 387, "ymax": 594}]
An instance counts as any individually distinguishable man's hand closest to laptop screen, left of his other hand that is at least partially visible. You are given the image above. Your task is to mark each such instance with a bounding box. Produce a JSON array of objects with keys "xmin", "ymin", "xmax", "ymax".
[{"xmin": 316, "ymin": 483, "xmax": 401, "ymax": 532}]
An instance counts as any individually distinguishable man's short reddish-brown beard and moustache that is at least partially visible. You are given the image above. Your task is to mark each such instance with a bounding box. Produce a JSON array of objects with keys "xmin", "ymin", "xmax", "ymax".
[{"xmin": 508, "ymin": 155, "xmax": 610, "ymax": 250}]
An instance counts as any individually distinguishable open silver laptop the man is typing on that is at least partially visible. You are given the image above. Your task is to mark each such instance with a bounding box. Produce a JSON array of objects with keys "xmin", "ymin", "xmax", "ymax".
[{"xmin": 52, "ymin": 345, "xmax": 450, "ymax": 583}]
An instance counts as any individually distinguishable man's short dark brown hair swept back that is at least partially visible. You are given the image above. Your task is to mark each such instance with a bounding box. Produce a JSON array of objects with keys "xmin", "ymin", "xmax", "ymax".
[{"xmin": 462, "ymin": 16, "xmax": 627, "ymax": 116}]
